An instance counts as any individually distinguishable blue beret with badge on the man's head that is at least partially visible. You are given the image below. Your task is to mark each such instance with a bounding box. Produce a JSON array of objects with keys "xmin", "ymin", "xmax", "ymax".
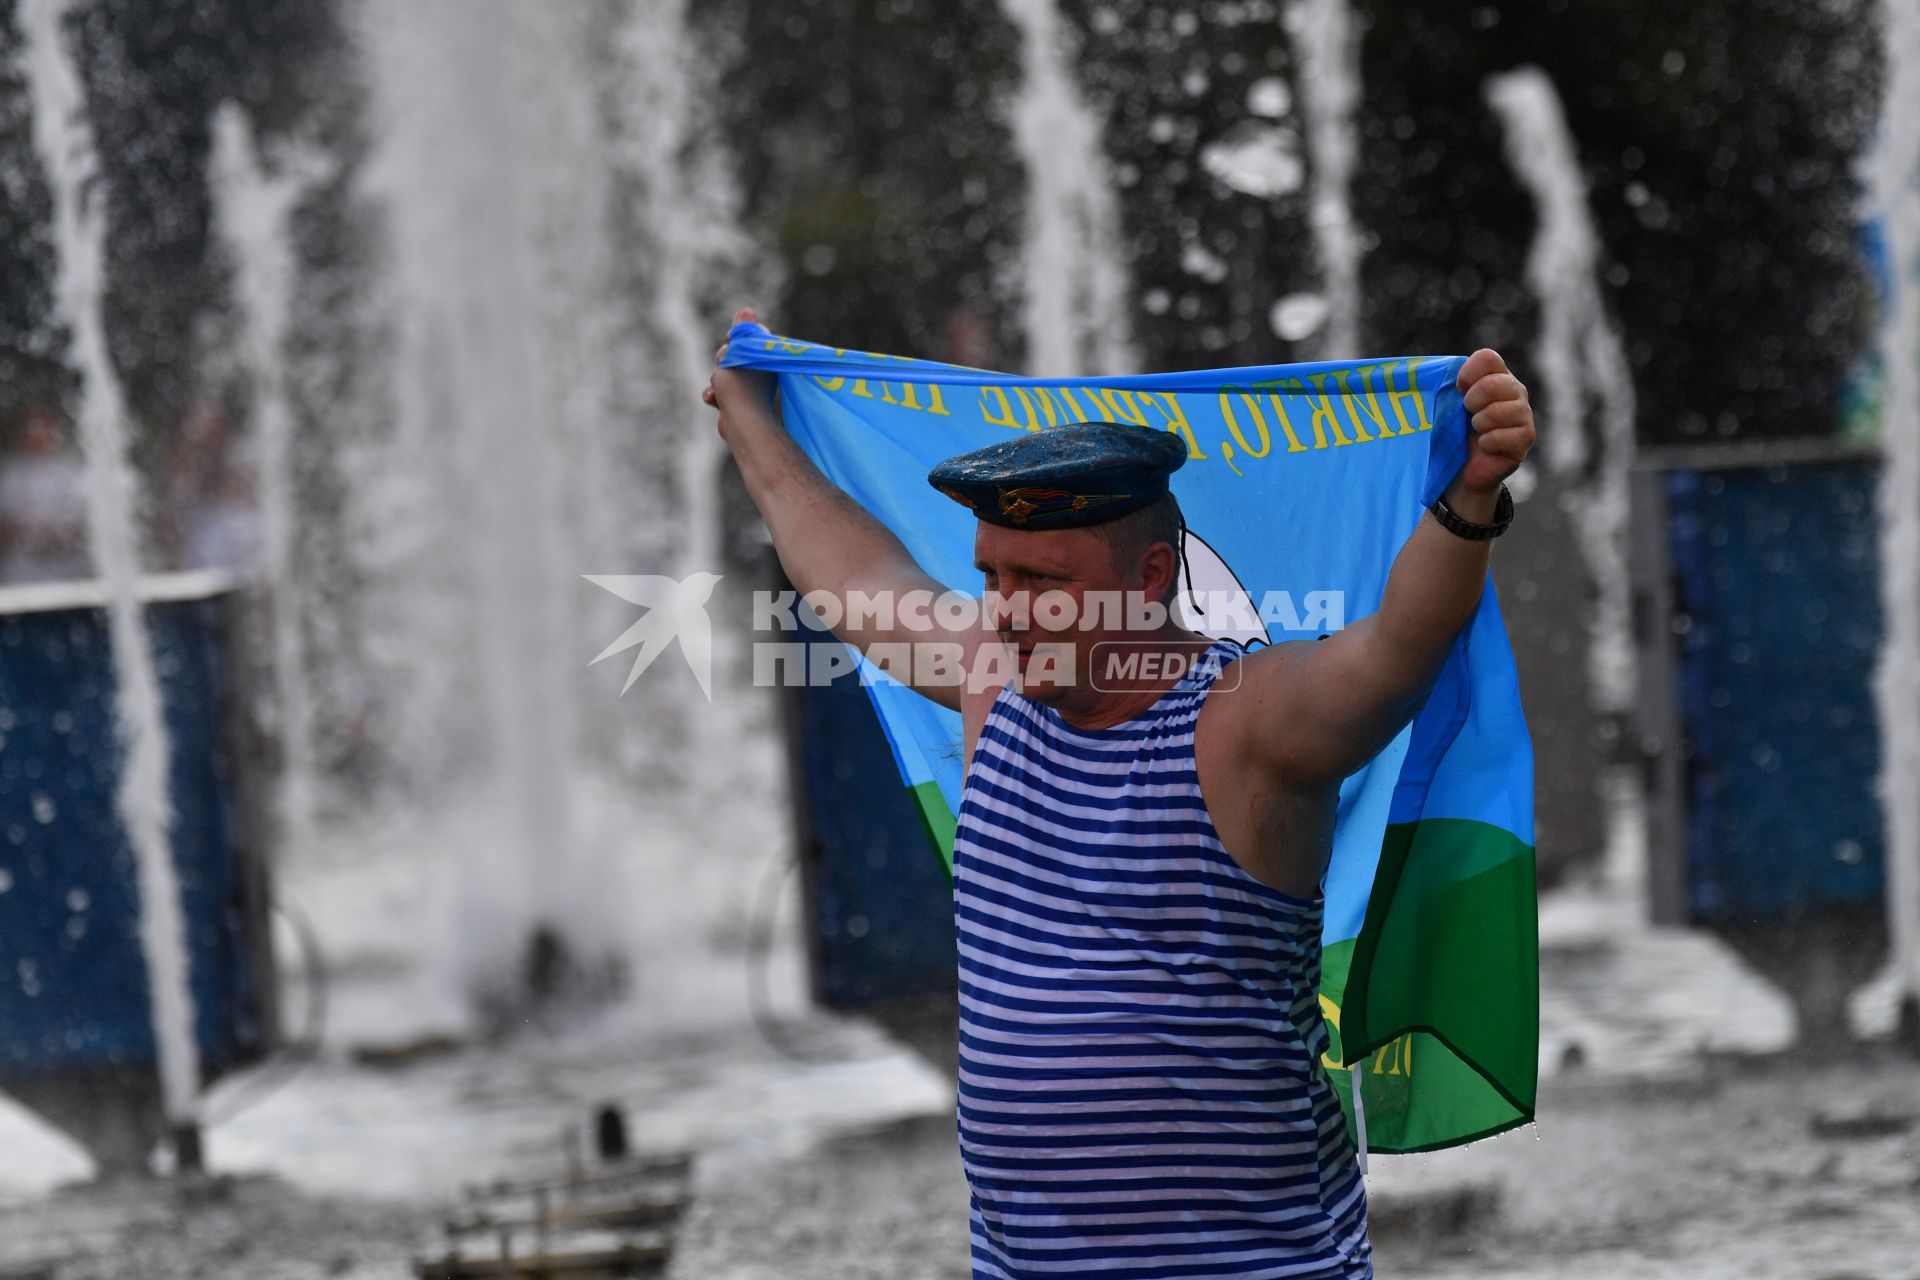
[{"xmin": 927, "ymin": 422, "xmax": 1187, "ymax": 530}]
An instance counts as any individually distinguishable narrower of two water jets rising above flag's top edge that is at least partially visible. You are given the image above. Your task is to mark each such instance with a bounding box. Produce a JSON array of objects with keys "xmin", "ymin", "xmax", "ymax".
[{"xmin": 1286, "ymin": 0, "xmax": 1361, "ymax": 359}]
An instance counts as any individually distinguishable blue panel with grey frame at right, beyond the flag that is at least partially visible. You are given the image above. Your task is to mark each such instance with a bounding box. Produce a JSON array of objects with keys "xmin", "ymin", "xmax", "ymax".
[{"xmin": 1634, "ymin": 439, "xmax": 1887, "ymax": 1048}]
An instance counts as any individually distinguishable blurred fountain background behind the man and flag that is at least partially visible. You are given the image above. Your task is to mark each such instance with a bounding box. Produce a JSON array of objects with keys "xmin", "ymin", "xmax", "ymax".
[{"xmin": 0, "ymin": 0, "xmax": 1920, "ymax": 1280}]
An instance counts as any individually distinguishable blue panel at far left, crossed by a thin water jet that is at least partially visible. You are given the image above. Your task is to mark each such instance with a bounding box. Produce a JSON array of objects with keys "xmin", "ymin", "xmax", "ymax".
[{"xmin": 0, "ymin": 572, "xmax": 276, "ymax": 1174}]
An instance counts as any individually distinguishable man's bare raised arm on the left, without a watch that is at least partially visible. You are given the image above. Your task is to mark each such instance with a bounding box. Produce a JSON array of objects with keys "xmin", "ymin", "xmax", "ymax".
[{"xmin": 701, "ymin": 307, "xmax": 995, "ymax": 710}]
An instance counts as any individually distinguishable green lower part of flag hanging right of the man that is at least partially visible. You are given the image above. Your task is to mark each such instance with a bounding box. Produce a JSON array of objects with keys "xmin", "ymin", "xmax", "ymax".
[{"xmin": 1321, "ymin": 818, "xmax": 1540, "ymax": 1153}]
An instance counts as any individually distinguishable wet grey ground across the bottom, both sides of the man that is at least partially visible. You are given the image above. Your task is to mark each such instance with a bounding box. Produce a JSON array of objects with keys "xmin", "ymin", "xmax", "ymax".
[{"xmin": 0, "ymin": 1023, "xmax": 1920, "ymax": 1280}]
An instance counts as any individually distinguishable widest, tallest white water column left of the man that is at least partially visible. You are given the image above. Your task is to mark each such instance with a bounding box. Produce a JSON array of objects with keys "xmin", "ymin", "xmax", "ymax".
[{"xmin": 361, "ymin": 0, "xmax": 607, "ymax": 996}]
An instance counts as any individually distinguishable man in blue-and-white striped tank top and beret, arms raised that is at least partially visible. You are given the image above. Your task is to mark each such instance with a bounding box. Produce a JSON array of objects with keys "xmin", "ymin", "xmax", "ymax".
[{"xmin": 705, "ymin": 311, "xmax": 1534, "ymax": 1280}]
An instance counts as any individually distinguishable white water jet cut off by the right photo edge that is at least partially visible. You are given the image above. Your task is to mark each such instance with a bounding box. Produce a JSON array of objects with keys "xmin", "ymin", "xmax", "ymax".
[{"xmin": 1872, "ymin": 0, "xmax": 1920, "ymax": 1000}]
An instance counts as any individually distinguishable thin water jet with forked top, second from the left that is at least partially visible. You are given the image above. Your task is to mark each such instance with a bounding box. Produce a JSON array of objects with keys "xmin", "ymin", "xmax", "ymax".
[{"xmin": 211, "ymin": 104, "xmax": 330, "ymax": 848}]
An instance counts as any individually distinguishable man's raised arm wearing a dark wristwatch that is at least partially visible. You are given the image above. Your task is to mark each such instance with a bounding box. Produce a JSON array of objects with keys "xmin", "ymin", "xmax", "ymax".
[{"xmin": 1240, "ymin": 349, "xmax": 1534, "ymax": 783}]
